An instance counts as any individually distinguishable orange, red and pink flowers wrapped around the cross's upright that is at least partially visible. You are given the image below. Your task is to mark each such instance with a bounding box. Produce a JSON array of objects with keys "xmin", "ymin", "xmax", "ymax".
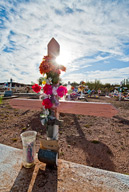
[{"xmin": 32, "ymin": 56, "xmax": 67, "ymax": 128}]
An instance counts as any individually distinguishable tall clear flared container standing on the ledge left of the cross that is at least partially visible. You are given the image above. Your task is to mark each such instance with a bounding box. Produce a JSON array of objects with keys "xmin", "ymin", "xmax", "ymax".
[{"xmin": 20, "ymin": 131, "xmax": 37, "ymax": 168}]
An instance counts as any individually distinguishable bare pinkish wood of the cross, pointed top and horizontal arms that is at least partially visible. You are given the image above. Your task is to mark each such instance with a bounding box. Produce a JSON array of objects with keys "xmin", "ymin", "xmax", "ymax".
[{"xmin": 10, "ymin": 38, "xmax": 117, "ymax": 140}]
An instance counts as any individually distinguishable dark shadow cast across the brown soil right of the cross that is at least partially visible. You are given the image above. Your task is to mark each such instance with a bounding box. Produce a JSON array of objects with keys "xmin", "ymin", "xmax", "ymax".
[{"xmin": 66, "ymin": 115, "xmax": 115, "ymax": 171}]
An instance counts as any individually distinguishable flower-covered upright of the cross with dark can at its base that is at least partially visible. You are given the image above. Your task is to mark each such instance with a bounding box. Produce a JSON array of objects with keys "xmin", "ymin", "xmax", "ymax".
[{"xmin": 32, "ymin": 38, "xmax": 68, "ymax": 166}]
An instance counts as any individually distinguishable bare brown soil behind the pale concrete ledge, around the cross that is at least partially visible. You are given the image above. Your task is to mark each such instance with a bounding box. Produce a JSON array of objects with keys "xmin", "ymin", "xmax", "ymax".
[{"xmin": 0, "ymin": 97, "xmax": 129, "ymax": 174}]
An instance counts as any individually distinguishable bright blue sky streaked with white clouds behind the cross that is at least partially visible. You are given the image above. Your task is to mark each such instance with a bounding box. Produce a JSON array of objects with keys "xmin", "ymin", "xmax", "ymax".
[{"xmin": 0, "ymin": 0, "xmax": 129, "ymax": 83}]
